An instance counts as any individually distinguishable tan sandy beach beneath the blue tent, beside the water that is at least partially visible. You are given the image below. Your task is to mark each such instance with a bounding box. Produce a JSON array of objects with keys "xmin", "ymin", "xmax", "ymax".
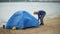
[{"xmin": 0, "ymin": 18, "xmax": 60, "ymax": 34}]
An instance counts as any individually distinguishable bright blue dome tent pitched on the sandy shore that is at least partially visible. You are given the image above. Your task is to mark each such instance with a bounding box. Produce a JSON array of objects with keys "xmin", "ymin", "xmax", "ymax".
[{"xmin": 5, "ymin": 11, "xmax": 39, "ymax": 29}]
